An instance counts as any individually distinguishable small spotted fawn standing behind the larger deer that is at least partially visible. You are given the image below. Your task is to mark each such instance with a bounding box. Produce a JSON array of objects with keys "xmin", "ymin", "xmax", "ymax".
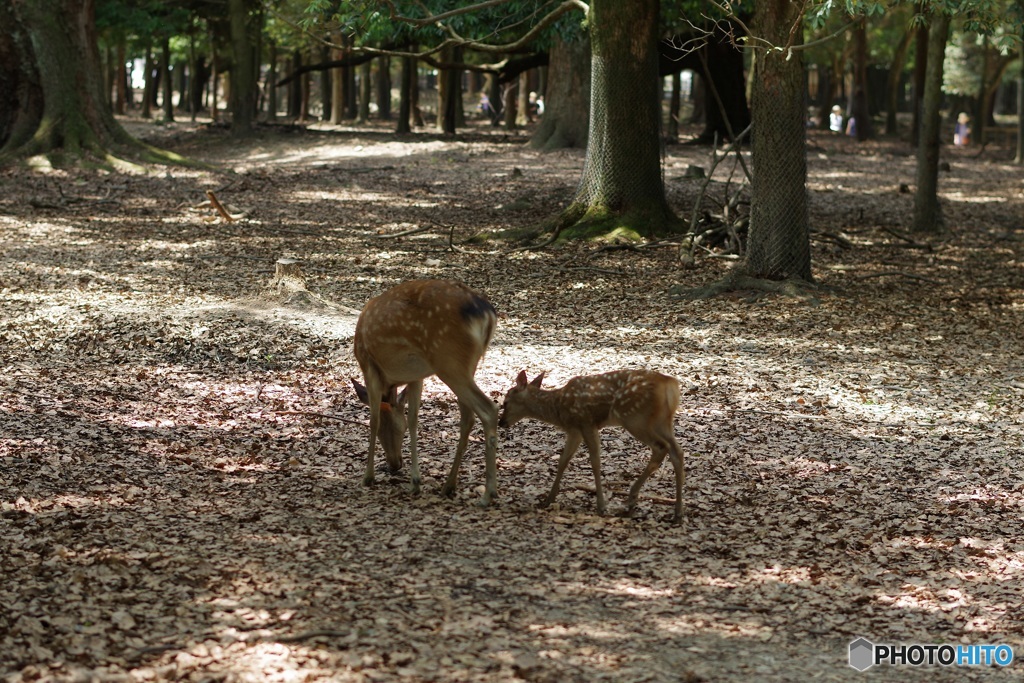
[{"xmin": 499, "ymin": 370, "xmax": 686, "ymax": 522}]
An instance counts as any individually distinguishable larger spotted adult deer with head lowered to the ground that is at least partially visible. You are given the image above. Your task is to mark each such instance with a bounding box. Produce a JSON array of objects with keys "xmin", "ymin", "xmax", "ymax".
[{"xmin": 352, "ymin": 280, "xmax": 498, "ymax": 506}]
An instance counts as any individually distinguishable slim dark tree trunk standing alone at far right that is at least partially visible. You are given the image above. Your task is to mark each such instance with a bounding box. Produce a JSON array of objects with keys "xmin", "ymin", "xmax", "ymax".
[{"xmin": 913, "ymin": 11, "xmax": 949, "ymax": 233}]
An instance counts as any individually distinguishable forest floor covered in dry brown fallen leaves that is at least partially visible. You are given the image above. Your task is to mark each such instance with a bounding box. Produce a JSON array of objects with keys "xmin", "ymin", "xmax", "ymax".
[{"xmin": 0, "ymin": 114, "xmax": 1024, "ymax": 683}]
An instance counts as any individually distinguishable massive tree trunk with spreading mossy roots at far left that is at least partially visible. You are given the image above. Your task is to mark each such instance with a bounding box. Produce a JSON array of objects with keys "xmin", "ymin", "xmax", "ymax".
[{"xmin": 0, "ymin": 0, "xmax": 159, "ymax": 161}]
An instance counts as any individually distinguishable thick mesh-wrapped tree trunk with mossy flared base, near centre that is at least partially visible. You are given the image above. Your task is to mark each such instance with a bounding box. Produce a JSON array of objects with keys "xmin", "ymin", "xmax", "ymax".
[{"xmin": 545, "ymin": 0, "xmax": 681, "ymax": 238}]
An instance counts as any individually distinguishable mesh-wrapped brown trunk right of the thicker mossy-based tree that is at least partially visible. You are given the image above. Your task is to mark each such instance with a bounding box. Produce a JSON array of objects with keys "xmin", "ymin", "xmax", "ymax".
[{"xmin": 742, "ymin": 0, "xmax": 811, "ymax": 282}]
